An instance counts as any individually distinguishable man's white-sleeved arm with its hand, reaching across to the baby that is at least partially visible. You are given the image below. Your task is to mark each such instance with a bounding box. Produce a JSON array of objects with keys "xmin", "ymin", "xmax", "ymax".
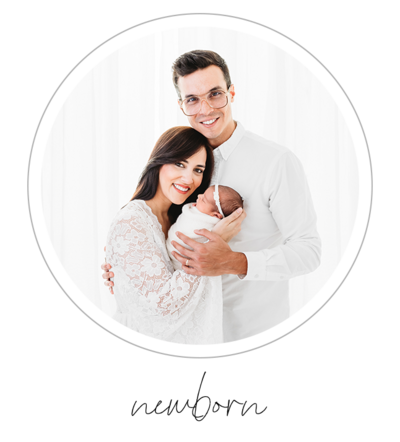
[{"xmin": 172, "ymin": 152, "xmax": 321, "ymax": 281}]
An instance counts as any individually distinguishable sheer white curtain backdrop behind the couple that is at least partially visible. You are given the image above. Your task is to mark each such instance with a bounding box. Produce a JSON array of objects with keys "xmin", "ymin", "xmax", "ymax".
[{"xmin": 42, "ymin": 28, "xmax": 358, "ymax": 315}]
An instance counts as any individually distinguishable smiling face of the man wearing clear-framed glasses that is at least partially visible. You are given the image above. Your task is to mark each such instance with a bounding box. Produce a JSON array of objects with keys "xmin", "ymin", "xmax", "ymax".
[{"xmin": 178, "ymin": 65, "xmax": 236, "ymax": 147}]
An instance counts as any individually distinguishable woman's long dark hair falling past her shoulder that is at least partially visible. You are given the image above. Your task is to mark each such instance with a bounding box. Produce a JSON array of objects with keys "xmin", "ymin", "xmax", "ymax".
[{"xmin": 130, "ymin": 126, "xmax": 214, "ymax": 223}]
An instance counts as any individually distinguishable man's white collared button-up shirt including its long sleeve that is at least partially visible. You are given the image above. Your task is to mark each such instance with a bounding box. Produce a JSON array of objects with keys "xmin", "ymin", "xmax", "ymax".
[{"xmin": 211, "ymin": 123, "xmax": 321, "ymax": 342}]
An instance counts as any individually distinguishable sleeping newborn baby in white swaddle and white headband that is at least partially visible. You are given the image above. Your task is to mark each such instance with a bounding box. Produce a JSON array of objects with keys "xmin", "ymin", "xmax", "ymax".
[{"xmin": 167, "ymin": 184, "xmax": 243, "ymax": 270}]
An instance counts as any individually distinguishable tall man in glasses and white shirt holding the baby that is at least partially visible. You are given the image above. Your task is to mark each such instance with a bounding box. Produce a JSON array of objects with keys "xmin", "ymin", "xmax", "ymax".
[{"xmin": 102, "ymin": 50, "xmax": 321, "ymax": 342}]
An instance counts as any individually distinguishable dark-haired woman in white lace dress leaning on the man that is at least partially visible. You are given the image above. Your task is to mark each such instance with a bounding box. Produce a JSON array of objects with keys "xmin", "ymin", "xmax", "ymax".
[{"xmin": 106, "ymin": 126, "xmax": 241, "ymax": 344}]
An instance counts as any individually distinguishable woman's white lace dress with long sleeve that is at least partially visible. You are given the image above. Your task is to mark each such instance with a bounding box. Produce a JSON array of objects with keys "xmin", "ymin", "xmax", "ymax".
[{"xmin": 106, "ymin": 200, "xmax": 222, "ymax": 344}]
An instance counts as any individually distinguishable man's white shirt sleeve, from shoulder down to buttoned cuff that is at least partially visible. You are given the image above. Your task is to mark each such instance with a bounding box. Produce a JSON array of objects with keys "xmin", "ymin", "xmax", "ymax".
[{"xmin": 239, "ymin": 152, "xmax": 321, "ymax": 281}]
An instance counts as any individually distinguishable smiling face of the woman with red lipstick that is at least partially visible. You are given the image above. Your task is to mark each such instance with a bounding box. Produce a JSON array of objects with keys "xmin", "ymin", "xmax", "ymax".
[{"xmin": 157, "ymin": 147, "xmax": 207, "ymax": 204}]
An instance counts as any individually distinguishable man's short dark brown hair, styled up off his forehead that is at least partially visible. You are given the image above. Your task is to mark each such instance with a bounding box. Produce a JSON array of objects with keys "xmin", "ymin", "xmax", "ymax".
[{"xmin": 172, "ymin": 49, "xmax": 232, "ymax": 100}]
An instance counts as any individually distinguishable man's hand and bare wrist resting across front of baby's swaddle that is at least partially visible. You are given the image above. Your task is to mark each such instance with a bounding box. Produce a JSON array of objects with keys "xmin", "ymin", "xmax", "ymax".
[{"xmin": 171, "ymin": 229, "xmax": 247, "ymax": 276}]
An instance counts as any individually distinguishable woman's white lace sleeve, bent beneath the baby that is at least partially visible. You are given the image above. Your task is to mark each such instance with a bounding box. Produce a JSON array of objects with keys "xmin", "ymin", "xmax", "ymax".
[{"xmin": 106, "ymin": 205, "xmax": 207, "ymax": 339}]
